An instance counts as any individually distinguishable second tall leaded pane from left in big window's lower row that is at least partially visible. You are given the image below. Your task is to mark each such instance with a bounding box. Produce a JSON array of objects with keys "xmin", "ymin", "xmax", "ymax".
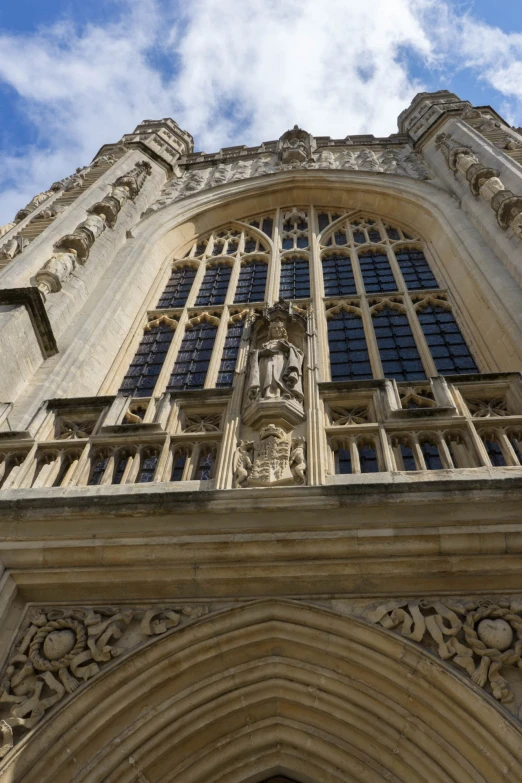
[{"xmin": 167, "ymin": 323, "xmax": 217, "ymax": 391}]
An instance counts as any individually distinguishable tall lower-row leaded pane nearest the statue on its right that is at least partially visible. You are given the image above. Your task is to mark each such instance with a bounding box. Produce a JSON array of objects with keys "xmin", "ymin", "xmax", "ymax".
[{"xmin": 328, "ymin": 313, "xmax": 372, "ymax": 381}]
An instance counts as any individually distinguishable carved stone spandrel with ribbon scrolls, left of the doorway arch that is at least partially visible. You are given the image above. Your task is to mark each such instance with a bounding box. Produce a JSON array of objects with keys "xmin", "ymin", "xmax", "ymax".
[{"xmin": 0, "ymin": 604, "xmax": 208, "ymax": 758}]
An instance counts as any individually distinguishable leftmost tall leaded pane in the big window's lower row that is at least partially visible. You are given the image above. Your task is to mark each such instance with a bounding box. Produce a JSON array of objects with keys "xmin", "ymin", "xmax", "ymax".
[{"xmin": 120, "ymin": 324, "xmax": 174, "ymax": 397}]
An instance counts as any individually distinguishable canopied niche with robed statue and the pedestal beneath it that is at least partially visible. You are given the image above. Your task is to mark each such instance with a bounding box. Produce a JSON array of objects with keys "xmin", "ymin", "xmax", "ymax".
[{"xmin": 243, "ymin": 302, "xmax": 305, "ymax": 431}]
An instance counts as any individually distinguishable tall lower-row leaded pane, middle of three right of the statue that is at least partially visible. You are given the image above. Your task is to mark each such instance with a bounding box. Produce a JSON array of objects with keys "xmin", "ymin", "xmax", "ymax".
[{"xmin": 373, "ymin": 307, "xmax": 426, "ymax": 381}]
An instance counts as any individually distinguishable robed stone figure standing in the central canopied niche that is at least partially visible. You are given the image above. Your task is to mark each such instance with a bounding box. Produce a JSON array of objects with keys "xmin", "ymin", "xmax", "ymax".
[{"xmin": 247, "ymin": 318, "xmax": 303, "ymax": 401}]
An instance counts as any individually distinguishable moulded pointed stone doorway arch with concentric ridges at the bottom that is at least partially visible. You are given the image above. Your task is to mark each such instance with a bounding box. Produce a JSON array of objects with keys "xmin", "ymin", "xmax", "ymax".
[{"xmin": 0, "ymin": 600, "xmax": 522, "ymax": 783}]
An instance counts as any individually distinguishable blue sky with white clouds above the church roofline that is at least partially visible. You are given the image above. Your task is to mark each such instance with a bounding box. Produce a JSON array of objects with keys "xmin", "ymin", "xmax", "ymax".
[{"xmin": 0, "ymin": 0, "xmax": 522, "ymax": 225}]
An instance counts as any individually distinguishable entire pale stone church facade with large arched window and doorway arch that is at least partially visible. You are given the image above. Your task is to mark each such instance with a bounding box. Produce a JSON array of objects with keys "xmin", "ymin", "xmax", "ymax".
[{"xmin": 0, "ymin": 91, "xmax": 522, "ymax": 783}]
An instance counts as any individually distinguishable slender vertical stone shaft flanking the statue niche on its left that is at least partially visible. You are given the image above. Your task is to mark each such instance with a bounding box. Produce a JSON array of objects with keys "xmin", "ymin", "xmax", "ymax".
[{"xmin": 215, "ymin": 316, "xmax": 253, "ymax": 489}]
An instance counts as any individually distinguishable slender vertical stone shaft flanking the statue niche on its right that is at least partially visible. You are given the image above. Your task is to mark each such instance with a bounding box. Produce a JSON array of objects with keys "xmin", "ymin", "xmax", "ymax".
[{"xmin": 305, "ymin": 305, "xmax": 327, "ymax": 485}]
